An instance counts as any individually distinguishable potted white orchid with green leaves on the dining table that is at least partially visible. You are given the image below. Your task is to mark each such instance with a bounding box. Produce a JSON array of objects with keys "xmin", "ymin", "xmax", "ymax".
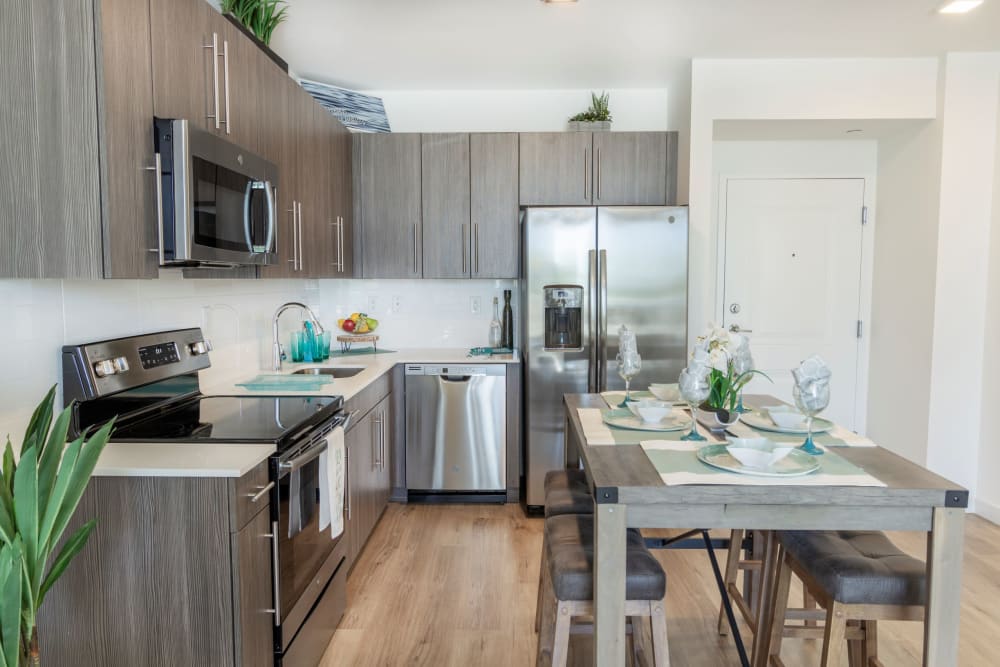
[{"xmin": 691, "ymin": 324, "xmax": 771, "ymax": 428}]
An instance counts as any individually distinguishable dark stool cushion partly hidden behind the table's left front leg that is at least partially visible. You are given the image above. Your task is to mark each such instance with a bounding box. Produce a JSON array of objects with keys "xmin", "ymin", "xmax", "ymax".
[{"xmin": 545, "ymin": 514, "xmax": 667, "ymax": 600}]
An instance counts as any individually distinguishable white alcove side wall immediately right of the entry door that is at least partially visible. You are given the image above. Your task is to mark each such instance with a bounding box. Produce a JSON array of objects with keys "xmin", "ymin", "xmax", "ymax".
[{"xmin": 867, "ymin": 120, "xmax": 942, "ymax": 464}]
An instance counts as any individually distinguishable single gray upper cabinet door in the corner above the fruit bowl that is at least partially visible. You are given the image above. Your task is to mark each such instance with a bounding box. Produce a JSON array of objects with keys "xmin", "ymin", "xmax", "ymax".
[{"xmin": 354, "ymin": 134, "xmax": 423, "ymax": 278}]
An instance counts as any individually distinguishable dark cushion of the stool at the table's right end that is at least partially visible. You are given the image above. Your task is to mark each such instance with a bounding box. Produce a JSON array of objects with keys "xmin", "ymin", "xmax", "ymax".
[{"xmin": 779, "ymin": 530, "xmax": 927, "ymax": 605}]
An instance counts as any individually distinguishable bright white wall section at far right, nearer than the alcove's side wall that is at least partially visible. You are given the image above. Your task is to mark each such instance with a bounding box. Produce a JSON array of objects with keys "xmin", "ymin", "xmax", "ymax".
[{"xmin": 927, "ymin": 53, "xmax": 1000, "ymax": 497}]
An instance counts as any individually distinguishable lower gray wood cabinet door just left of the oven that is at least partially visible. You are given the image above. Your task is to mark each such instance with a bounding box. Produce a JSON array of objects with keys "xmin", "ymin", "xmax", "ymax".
[{"xmin": 233, "ymin": 509, "xmax": 274, "ymax": 667}]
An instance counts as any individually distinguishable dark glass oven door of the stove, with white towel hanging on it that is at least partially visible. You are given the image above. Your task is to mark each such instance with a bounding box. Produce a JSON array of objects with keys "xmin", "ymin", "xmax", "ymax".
[{"xmin": 271, "ymin": 413, "xmax": 348, "ymax": 652}]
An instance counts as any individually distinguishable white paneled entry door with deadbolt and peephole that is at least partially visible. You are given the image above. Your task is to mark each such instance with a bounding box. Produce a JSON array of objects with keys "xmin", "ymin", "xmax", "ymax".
[{"xmin": 723, "ymin": 178, "xmax": 865, "ymax": 428}]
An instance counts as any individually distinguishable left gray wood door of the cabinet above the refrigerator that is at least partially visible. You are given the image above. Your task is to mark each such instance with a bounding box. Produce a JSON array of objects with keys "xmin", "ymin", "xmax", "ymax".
[{"xmin": 520, "ymin": 132, "xmax": 593, "ymax": 206}]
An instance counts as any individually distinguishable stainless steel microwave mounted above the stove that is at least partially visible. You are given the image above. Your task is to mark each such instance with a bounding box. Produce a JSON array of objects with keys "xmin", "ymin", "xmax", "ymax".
[{"xmin": 154, "ymin": 118, "xmax": 278, "ymax": 267}]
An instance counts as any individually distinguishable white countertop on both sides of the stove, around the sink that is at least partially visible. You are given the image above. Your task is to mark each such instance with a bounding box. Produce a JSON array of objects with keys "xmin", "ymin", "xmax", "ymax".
[{"xmin": 94, "ymin": 348, "xmax": 521, "ymax": 477}]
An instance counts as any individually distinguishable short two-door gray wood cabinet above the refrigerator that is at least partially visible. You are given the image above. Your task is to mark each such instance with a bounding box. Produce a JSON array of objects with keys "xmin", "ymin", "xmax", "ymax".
[{"xmin": 520, "ymin": 132, "xmax": 677, "ymax": 206}]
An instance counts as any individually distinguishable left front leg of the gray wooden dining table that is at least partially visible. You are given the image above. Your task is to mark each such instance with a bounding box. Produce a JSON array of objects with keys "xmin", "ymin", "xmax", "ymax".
[{"xmin": 594, "ymin": 503, "xmax": 626, "ymax": 667}]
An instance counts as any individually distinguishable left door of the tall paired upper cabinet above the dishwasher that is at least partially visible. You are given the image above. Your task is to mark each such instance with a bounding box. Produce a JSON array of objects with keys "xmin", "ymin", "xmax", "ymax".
[{"xmin": 420, "ymin": 134, "xmax": 472, "ymax": 278}]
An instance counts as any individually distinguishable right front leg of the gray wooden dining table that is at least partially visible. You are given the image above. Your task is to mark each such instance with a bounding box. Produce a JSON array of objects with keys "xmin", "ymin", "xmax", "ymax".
[{"xmin": 924, "ymin": 507, "xmax": 965, "ymax": 667}]
